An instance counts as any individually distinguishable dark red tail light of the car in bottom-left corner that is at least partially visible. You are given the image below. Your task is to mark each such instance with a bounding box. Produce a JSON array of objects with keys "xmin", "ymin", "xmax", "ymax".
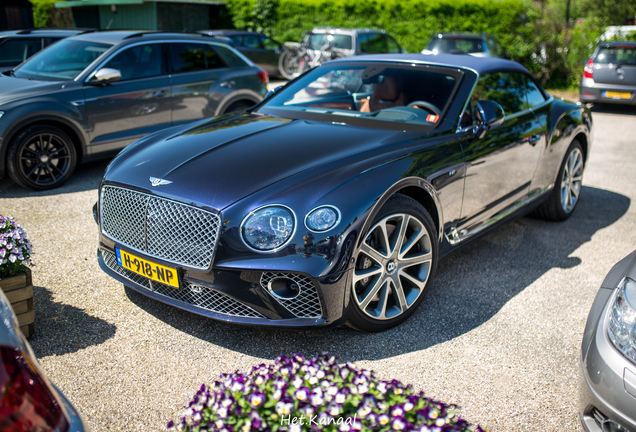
[{"xmin": 0, "ymin": 346, "xmax": 69, "ymax": 432}]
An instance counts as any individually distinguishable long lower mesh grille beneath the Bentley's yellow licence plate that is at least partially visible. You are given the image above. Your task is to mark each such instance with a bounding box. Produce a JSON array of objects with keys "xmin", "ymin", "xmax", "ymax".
[{"xmin": 101, "ymin": 249, "xmax": 265, "ymax": 318}]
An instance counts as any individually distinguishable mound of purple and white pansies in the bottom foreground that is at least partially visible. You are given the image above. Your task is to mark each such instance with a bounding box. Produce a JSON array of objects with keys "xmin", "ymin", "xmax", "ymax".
[{"xmin": 168, "ymin": 354, "xmax": 483, "ymax": 432}]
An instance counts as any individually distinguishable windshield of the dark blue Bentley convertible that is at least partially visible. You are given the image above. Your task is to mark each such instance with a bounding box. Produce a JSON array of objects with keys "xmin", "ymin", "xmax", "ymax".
[{"xmin": 258, "ymin": 63, "xmax": 461, "ymax": 129}]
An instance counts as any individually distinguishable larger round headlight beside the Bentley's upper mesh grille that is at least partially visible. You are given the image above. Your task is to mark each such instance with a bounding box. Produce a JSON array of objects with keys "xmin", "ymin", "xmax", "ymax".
[{"xmin": 241, "ymin": 205, "xmax": 296, "ymax": 252}]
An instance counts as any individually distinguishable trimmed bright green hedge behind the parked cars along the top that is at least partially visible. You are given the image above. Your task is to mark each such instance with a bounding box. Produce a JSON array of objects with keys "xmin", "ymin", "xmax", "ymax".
[{"xmin": 229, "ymin": 0, "xmax": 529, "ymax": 52}]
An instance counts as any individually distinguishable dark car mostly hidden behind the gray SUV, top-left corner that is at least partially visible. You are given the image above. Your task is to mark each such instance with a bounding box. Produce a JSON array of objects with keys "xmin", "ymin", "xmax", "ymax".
[{"xmin": 0, "ymin": 28, "xmax": 93, "ymax": 70}]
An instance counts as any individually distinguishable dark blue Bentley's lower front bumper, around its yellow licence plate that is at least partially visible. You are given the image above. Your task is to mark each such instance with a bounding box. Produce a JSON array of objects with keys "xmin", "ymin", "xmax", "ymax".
[{"xmin": 97, "ymin": 242, "xmax": 350, "ymax": 328}]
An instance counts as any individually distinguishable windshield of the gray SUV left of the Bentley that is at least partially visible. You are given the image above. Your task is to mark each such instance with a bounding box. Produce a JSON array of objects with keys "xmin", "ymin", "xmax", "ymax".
[{"xmin": 15, "ymin": 39, "xmax": 112, "ymax": 81}]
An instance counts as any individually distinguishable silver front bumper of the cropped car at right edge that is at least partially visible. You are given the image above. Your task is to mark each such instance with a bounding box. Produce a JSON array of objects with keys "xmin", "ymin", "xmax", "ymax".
[{"xmin": 579, "ymin": 289, "xmax": 636, "ymax": 432}]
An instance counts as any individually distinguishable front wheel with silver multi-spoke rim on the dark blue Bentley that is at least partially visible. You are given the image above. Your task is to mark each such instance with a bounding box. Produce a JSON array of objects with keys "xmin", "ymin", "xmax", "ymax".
[{"xmin": 347, "ymin": 194, "xmax": 438, "ymax": 332}]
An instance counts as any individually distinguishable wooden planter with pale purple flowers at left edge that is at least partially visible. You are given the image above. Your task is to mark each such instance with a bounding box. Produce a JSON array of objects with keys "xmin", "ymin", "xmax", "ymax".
[{"xmin": 0, "ymin": 215, "xmax": 35, "ymax": 337}]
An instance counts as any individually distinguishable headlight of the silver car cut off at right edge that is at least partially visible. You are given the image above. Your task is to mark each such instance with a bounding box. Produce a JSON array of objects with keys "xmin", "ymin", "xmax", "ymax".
[{"xmin": 607, "ymin": 278, "xmax": 636, "ymax": 362}]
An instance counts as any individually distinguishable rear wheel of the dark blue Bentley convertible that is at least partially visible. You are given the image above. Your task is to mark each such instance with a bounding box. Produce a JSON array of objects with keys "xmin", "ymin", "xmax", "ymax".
[{"xmin": 535, "ymin": 140, "xmax": 585, "ymax": 221}]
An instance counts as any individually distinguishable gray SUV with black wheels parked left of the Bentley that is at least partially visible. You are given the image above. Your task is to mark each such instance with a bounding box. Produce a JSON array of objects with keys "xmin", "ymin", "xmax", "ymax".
[{"xmin": 0, "ymin": 31, "xmax": 268, "ymax": 190}]
